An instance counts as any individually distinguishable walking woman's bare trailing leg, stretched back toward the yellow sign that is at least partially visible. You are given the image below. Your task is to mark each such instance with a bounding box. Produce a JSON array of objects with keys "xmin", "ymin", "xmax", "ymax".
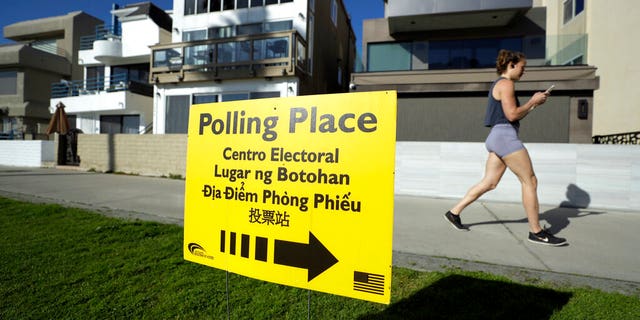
[{"xmin": 450, "ymin": 152, "xmax": 507, "ymax": 214}]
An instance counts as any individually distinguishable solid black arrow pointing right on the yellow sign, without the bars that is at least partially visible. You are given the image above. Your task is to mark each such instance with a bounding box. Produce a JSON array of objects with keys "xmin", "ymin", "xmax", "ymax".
[{"xmin": 273, "ymin": 232, "xmax": 338, "ymax": 282}]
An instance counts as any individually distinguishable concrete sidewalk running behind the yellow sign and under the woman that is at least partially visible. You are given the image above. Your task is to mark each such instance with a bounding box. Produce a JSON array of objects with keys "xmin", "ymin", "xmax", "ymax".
[{"xmin": 0, "ymin": 166, "xmax": 640, "ymax": 295}]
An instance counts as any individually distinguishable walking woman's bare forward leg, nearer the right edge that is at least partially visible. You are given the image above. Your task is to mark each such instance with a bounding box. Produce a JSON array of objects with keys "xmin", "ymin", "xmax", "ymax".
[{"xmin": 502, "ymin": 149, "xmax": 542, "ymax": 233}]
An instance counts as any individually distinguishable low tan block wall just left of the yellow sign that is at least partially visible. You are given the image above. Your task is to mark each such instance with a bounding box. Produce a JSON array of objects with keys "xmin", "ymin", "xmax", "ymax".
[{"xmin": 78, "ymin": 134, "xmax": 187, "ymax": 177}]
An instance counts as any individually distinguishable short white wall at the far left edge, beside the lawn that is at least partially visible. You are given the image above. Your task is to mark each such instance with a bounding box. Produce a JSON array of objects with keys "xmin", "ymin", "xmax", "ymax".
[{"xmin": 0, "ymin": 140, "xmax": 55, "ymax": 167}]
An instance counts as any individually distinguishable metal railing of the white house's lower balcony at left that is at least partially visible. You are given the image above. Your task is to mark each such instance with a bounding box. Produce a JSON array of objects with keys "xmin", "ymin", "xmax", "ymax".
[{"xmin": 51, "ymin": 74, "xmax": 130, "ymax": 98}]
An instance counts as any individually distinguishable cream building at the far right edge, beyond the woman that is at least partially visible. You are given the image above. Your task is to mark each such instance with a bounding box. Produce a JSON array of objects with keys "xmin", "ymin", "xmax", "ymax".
[{"xmin": 541, "ymin": 0, "xmax": 640, "ymax": 141}]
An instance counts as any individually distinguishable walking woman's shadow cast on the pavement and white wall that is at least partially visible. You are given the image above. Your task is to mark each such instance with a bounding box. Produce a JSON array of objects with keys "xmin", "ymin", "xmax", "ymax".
[{"xmin": 466, "ymin": 183, "xmax": 605, "ymax": 234}]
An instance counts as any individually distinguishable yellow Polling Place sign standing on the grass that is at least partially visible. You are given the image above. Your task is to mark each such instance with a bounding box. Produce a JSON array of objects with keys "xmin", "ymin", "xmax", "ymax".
[{"xmin": 184, "ymin": 91, "xmax": 396, "ymax": 303}]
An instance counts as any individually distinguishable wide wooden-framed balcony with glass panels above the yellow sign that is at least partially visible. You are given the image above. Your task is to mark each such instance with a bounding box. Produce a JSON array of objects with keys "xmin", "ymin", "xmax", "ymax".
[{"xmin": 150, "ymin": 30, "xmax": 307, "ymax": 83}]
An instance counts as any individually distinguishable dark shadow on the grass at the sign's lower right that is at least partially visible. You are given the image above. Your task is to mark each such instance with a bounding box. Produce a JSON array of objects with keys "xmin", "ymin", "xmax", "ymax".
[{"xmin": 359, "ymin": 275, "xmax": 572, "ymax": 320}]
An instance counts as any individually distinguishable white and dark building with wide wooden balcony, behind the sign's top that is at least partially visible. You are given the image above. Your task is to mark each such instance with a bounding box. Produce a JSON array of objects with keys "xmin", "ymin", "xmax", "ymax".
[{"xmin": 150, "ymin": 0, "xmax": 355, "ymax": 134}]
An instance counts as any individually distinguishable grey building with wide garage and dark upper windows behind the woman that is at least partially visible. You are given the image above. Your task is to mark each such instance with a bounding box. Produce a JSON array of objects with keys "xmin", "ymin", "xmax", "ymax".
[{"xmin": 351, "ymin": 0, "xmax": 601, "ymax": 143}]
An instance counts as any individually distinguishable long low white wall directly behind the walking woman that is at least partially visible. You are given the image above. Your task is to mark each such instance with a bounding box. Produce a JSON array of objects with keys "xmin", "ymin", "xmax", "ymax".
[{"xmin": 395, "ymin": 142, "xmax": 640, "ymax": 211}]
